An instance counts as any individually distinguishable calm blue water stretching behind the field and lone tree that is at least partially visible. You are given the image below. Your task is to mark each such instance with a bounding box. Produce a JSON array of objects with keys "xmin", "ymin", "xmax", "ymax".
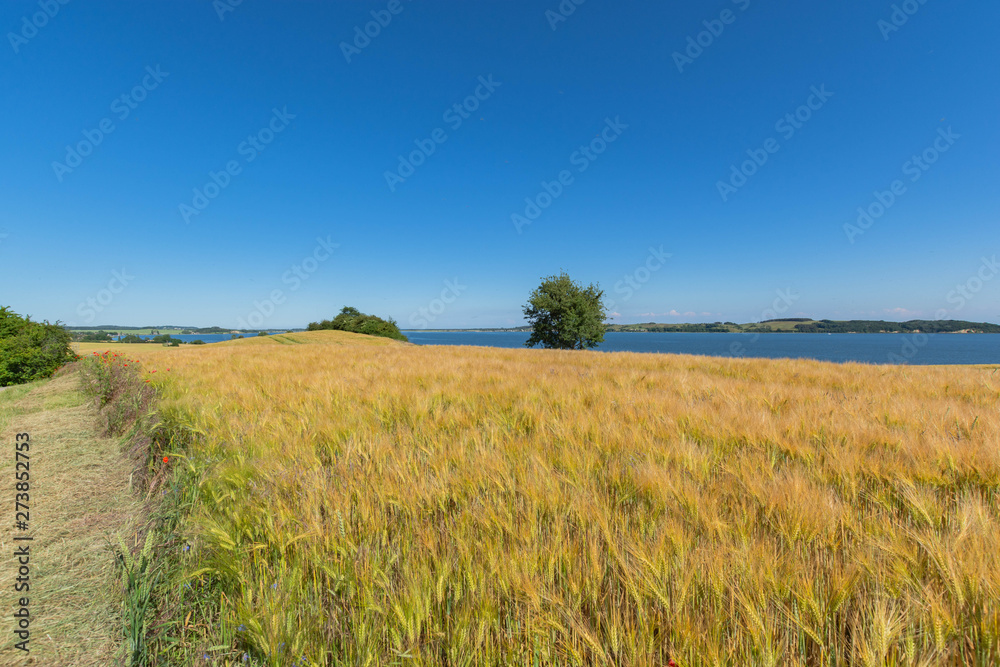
[{"xmin": 404, "ymin": 331, "xmax": 1000, "ymax": 364}]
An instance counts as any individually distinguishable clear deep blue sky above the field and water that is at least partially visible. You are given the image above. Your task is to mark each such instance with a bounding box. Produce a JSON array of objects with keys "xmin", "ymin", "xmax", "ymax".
[{"xmin": 0, "ymin": 0, "xmax": 1000, "ymax": 328}]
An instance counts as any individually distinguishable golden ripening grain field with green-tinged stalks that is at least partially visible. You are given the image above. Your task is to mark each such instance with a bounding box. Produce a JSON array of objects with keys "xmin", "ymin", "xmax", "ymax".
[{"xmin": 74, "ymin": 332, "xmax": 1000, "ymax": 666}]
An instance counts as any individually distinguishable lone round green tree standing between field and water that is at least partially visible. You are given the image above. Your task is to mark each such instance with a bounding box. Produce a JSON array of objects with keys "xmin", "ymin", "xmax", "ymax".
[{"xmin": 524, "ymin": 271, "xmax": 607, "ymax": 350}]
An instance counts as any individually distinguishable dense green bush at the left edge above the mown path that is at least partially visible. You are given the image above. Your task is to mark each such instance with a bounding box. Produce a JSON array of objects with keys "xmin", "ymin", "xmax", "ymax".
[{"xmin": 0, "ymin": 306, "xmax": 76, "ymax": 387}]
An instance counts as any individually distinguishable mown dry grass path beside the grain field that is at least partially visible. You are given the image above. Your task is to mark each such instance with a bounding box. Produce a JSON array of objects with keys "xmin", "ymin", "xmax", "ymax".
[{"xmin": 0, "ymin": 372, "xmax": 141, "ymax": 666}]
